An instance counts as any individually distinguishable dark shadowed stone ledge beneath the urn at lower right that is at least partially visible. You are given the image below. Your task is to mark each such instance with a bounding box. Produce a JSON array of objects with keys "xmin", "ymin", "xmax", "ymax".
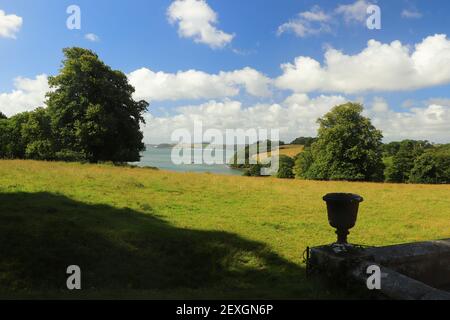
[{"xmin": 308, "ymin": 239, "xmax": 450, "ymax": 300}]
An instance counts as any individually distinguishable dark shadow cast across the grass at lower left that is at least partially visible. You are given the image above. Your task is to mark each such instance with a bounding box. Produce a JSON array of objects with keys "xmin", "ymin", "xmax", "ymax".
[{"xmin": 0, "ymin": 193, "xmax": 340, "ymax": 299}]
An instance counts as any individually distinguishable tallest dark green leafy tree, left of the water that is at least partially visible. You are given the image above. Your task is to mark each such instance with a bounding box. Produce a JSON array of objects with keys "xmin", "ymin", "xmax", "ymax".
[{"xmin": 47, "ymin": 48, "xmax": 148, "ymax": 162}]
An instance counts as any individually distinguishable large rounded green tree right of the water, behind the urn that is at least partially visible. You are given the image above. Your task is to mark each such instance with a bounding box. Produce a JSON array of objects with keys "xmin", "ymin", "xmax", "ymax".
[{"xmin": 301, "ymin": 103, "xmax": 384, "ymax": 181}]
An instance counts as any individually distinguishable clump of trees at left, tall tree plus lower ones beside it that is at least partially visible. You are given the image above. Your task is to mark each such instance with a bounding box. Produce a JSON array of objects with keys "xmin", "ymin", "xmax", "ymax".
[{"xmin": 0, "ymin": 48, "xmax": 148, "ymax": 162}]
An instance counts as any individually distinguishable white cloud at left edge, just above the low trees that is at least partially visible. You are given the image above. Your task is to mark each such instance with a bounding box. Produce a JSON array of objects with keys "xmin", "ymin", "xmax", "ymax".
[{"xmin": 0, "ymin": 74, "xmax": 49, "ymax": 117}]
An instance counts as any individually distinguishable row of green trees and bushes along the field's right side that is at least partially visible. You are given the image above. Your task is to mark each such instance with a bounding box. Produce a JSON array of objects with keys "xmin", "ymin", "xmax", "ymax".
[{"xmin": 235, "ymin": 103, "xmax": 450, "ymax": 184}]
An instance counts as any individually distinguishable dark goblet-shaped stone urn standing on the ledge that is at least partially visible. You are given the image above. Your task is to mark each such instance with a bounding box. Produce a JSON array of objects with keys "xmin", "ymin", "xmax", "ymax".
[{"xmin": 323, "ymin": 193, "xmax": 364, "ymax": 245}]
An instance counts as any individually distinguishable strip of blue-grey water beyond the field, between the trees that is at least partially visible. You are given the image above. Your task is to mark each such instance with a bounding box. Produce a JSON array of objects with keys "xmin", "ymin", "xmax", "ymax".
[{"xmin": 133, "ymin": 146, "xmax": 242, "ymax": 176}]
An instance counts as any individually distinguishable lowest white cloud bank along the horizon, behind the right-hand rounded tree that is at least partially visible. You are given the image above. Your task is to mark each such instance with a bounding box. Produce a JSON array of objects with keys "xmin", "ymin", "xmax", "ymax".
[{"xmin": 143, "ymin": 93, "xmax": 450, "ymax": 143}]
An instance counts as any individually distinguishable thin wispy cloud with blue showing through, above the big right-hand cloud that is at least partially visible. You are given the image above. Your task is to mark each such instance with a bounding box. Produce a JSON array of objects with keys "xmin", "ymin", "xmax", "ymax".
[{"xmin": 277, "ymin": 6, "xmax": 331, "ymax": 38}]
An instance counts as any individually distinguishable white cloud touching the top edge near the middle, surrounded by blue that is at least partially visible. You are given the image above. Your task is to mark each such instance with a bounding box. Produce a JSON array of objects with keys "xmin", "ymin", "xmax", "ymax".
[{"xmin": 167, "ymin": 0, "xmax": 234, "ymax": 48}]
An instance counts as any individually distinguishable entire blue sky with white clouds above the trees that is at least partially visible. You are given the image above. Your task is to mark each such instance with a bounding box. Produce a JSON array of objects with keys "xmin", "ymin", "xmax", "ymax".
[{"xmin": 0, "ymin": 0, "xmax": 450, "ymax": 143}]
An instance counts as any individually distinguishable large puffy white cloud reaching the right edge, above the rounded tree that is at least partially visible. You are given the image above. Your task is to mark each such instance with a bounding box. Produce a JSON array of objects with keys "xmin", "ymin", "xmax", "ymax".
[{"xmin": 275, "ymin": 34, "xmax": 450, "ymax": 93}]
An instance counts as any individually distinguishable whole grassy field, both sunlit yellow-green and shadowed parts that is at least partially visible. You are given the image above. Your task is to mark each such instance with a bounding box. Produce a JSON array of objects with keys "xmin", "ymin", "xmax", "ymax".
[{"xmin": 0, "ymin": 161, "xmax": 450, "ymax": 299}]
